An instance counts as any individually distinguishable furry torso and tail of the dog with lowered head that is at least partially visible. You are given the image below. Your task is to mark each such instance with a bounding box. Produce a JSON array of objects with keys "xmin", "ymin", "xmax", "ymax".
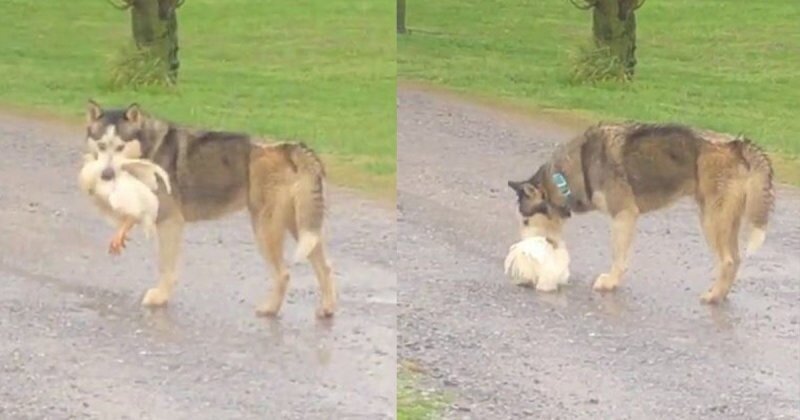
[{"xmin": 578, "ymin": 124, "xmax": 773, "ymax": 228}]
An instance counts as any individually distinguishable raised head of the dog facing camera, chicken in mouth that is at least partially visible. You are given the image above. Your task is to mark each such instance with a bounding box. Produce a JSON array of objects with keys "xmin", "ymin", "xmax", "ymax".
[{"xmin": 86, "ymin": 100, "xmax": 145, "ymax": 180}]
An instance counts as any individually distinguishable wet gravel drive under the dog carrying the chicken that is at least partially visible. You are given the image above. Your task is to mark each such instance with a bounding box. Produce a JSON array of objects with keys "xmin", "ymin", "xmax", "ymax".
[{"xmin": 0, "ymin": 115, "xmax": 396, "ymax": 419}]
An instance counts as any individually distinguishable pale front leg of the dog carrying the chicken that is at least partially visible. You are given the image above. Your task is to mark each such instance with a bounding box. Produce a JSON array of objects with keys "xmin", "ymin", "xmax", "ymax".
[{"xmin": 142, "ymin": 216, "xmax": 184, "ymax": 306}]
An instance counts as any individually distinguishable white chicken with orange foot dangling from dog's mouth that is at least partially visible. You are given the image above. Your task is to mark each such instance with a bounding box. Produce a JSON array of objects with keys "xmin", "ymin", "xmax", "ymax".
[{"xmin": 78, "ymin": 154, "xmax": 171, "ymax": 254}]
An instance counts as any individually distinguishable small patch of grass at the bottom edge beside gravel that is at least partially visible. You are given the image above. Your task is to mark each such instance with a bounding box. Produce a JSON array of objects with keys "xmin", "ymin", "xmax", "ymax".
[{"xmin": 397, "ymin": 367, "xmax": 446, "ymax": 420}]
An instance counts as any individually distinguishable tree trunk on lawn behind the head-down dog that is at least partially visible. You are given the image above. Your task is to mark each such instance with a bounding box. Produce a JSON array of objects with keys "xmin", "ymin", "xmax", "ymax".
[{"xmin": 592, "ymin": 0, "xmax": 637, "ymax": 78}]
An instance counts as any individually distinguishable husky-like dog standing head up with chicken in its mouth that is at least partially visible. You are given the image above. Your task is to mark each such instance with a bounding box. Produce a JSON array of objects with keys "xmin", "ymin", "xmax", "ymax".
[{"xmin": 86, "ymin": 100, "xmax": 336, "ymax": 318}]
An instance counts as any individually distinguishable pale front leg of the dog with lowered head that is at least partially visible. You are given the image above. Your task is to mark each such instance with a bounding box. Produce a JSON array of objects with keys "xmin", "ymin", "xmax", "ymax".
[{"xmin": 593, "ymin": 209, "xmax": 639, "ymax": 291}]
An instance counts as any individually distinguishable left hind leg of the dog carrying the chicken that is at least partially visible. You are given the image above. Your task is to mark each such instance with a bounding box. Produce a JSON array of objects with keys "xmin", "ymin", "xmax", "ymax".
[{"xmin": 251, "ymin": 206, "xmax": 289, "ymax": 316}]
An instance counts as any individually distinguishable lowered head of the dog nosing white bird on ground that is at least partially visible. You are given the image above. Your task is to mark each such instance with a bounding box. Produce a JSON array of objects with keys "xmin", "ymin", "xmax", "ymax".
[{"xmin": 508, "ymin": 166, "xmax": 572, "ymax": 237}]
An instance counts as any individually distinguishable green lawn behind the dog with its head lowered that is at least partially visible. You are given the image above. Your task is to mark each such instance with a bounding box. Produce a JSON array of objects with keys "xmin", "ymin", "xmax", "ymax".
[{"xmin": 398, "ymin": 0, "xmax": 800, "ymax": 172}]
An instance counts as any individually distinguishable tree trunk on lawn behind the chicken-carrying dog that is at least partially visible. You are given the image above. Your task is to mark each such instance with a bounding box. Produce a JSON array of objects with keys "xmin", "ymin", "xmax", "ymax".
[{"xmin": 131, "ymin": 0, "xmax": 180, "ymax": 83}]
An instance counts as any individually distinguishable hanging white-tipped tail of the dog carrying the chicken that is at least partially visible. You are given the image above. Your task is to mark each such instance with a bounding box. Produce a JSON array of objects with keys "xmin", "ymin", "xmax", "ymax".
[{"xmin": 288, "ymin": 142, "xmax": 325, "ymax": 263}]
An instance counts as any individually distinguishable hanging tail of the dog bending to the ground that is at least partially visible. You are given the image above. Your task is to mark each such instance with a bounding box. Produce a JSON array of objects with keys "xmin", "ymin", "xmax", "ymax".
[{"xmin": 740, "ymin": 139, "xmax": 775, "ymax": 255}]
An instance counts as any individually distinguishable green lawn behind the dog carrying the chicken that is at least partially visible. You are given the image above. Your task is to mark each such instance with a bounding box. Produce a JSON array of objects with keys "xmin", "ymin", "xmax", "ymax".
[{"xmin": 0, "ymin": 0, "xmax": 396, "ymax": 196}]
